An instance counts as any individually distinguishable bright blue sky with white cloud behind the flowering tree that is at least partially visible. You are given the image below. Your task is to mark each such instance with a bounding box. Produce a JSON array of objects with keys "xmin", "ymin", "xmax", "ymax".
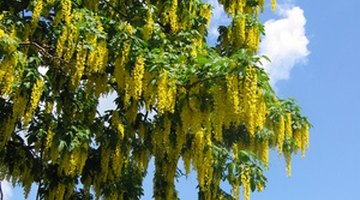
[{"xmin": 3, "ymin": 0, "xmax": 360, "ymax": 200}]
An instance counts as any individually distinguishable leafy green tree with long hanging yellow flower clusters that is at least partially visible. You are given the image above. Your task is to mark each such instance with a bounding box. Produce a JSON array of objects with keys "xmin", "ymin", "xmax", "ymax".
[{"xmin": 0, "ymin": 0, "xmax": 309, "ymax": 200}]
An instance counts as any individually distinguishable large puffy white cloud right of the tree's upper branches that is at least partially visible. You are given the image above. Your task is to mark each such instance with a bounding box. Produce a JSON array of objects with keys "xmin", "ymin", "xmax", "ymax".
[{"xmin": 260, "ymin": 4, "xmax": 310, "ymax": 85}]
